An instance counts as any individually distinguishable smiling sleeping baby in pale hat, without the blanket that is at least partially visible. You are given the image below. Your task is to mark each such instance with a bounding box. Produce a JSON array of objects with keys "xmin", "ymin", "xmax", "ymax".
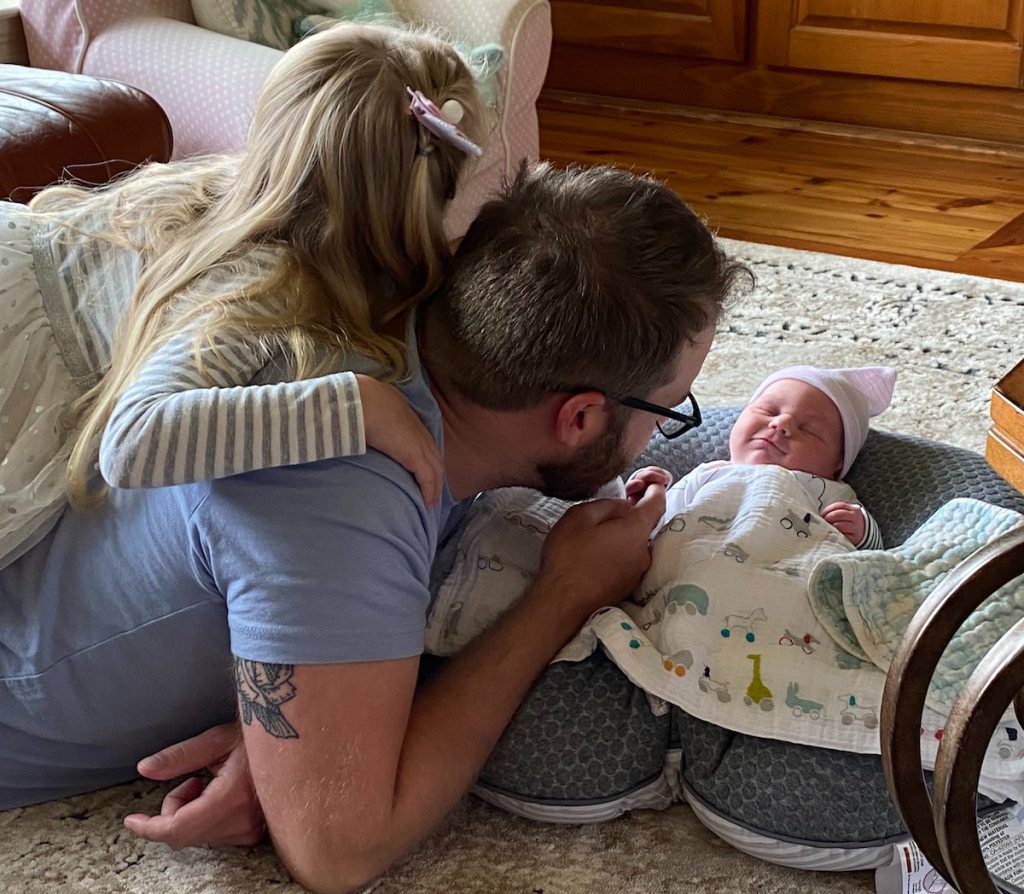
[{"xmin": 626, "ymin": 366, "xmax": 896, "ymax": 549}]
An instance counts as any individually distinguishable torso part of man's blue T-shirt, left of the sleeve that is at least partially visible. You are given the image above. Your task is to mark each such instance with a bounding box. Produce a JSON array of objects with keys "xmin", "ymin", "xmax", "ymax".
[{"xmin": 0, "ymin": 477, "xmax": 232, "ymax": 808}]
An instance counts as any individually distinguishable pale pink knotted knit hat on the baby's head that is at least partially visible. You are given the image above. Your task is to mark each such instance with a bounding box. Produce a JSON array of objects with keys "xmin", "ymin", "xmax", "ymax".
[{"xmin": 751, "ymin": 367, "xmax": 896, "ymax": 478}]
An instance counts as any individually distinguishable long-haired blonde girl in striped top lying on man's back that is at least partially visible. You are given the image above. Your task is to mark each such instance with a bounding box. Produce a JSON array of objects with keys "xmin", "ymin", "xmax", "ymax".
[{"xmin": 0, "ymin": 23, "xmax": 482, "ymax": 566}]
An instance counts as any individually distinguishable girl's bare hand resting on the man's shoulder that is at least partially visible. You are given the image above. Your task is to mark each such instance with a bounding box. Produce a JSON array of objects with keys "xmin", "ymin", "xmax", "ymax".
[{"xmin": 355, "ymin": 374, "xmax": 444, "ymax": 507}]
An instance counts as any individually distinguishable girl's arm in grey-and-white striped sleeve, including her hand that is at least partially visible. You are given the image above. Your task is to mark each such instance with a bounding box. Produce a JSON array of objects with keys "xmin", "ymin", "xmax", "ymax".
[{"xmin": 99, "ymin": 321, "xmax": 443, "ymax": 505}]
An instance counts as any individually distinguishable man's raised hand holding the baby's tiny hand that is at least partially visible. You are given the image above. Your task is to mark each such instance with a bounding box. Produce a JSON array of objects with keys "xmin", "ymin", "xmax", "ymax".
[{"xmin": 541, "ymin": 481, "xmax": 665, "ymax": 623}]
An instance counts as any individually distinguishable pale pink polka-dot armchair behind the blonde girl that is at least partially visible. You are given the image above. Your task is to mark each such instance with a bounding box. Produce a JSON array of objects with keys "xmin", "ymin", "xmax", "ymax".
[{"xmin": 22, "ymin": 0, "xmax": 551, "ymax": 236}]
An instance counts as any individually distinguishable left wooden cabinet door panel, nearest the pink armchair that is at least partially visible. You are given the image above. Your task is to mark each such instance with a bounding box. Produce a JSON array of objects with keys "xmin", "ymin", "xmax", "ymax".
[{"xmin": 551, "ymin": 0, "xmax": 746, "ymax": 61}]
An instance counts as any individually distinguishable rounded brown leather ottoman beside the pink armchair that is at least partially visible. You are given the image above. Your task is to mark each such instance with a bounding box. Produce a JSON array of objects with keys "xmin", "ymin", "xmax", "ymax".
[{"xmin": 0, "ymin": 65, "xmax": 172, "ymax": 202}]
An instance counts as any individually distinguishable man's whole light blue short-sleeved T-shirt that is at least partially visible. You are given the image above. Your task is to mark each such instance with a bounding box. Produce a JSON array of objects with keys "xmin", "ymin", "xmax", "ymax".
[{"xmin": 0, "ymin": 354, "xmax": 457, "ymax": 809}]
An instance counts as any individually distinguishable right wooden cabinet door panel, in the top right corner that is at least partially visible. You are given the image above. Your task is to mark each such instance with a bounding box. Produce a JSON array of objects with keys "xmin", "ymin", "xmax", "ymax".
[{"xmin": 758, "ymin": 0, "xmax": 1024, "ymax": 87}]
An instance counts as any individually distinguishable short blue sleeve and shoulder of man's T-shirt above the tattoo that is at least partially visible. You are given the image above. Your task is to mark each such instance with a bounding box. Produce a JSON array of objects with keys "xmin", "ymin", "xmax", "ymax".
[{"xmin": 194, "ymin": 454, "xmax": 452, "ymax": 664}]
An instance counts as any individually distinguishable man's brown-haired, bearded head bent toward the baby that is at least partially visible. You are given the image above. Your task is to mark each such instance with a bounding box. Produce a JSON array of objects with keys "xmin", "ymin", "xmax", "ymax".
[{"xmin": 427, "ymin": 163, "xmax": 749, "ymax": 497}]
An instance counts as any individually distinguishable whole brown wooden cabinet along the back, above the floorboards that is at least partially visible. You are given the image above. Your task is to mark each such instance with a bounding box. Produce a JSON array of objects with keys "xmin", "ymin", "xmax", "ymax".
[{"xmin": 546, "ymin": 0, "xmax": 1024, "ymax": 144}]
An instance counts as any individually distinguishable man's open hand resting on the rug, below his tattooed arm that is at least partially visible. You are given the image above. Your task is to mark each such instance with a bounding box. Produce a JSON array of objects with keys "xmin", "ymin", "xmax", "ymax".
[{"xmin": 124, "ymin": 723, "xmax": 266, "ymax": 849}]
